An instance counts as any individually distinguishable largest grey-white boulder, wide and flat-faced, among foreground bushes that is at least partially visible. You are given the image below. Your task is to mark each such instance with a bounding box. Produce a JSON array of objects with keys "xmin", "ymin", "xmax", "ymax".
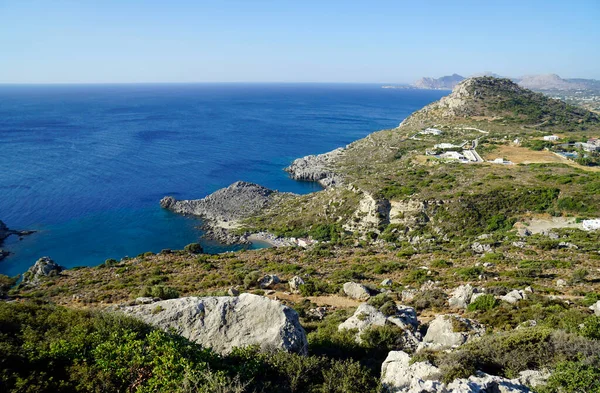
[{"xmin": 121, "ymin": 293, "xmax": 308, "ymax": 354}]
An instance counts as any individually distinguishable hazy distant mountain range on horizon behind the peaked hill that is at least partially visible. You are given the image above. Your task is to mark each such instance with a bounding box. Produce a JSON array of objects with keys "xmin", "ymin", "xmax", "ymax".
[{"xmin": 412, "ymin": 72, "xmax": 600, "ymax": 91}]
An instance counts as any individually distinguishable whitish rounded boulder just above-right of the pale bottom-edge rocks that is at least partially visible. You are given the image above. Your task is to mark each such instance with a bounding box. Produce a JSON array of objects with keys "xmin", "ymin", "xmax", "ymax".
[{"xmin": 423, "ymin": 315, "xmax": 485, "ymax": 350}]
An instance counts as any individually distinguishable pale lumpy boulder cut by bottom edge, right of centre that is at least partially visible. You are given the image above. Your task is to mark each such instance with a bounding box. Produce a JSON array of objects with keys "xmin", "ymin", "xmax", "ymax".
[{"xmin": 381, "ymin": 351, "xmax": 442, "ymax": 392}]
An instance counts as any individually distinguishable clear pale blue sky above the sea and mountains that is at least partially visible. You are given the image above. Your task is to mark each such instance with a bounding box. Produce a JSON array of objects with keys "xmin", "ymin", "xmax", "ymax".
[{"xmin": 0, "ymin": 0, "xmax": 600, "ymax": 83}]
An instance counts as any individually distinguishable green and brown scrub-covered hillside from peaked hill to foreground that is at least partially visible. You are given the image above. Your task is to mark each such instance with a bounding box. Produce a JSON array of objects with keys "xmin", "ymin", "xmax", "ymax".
[{"xmin": 0, "ymin": 77, "xmax": 600, "ymax": 393}]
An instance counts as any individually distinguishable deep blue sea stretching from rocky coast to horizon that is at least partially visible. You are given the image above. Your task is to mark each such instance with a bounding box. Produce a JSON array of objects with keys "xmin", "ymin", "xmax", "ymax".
[{"xmin": 0, "ymin": 84, "xmax": 447, "ymax": 275}]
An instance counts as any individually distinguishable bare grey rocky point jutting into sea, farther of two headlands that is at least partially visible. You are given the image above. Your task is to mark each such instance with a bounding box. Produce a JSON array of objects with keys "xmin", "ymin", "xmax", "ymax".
[{"xmin": 284, "ymin": 148, "xmax": 345, "ymax": 188}]
